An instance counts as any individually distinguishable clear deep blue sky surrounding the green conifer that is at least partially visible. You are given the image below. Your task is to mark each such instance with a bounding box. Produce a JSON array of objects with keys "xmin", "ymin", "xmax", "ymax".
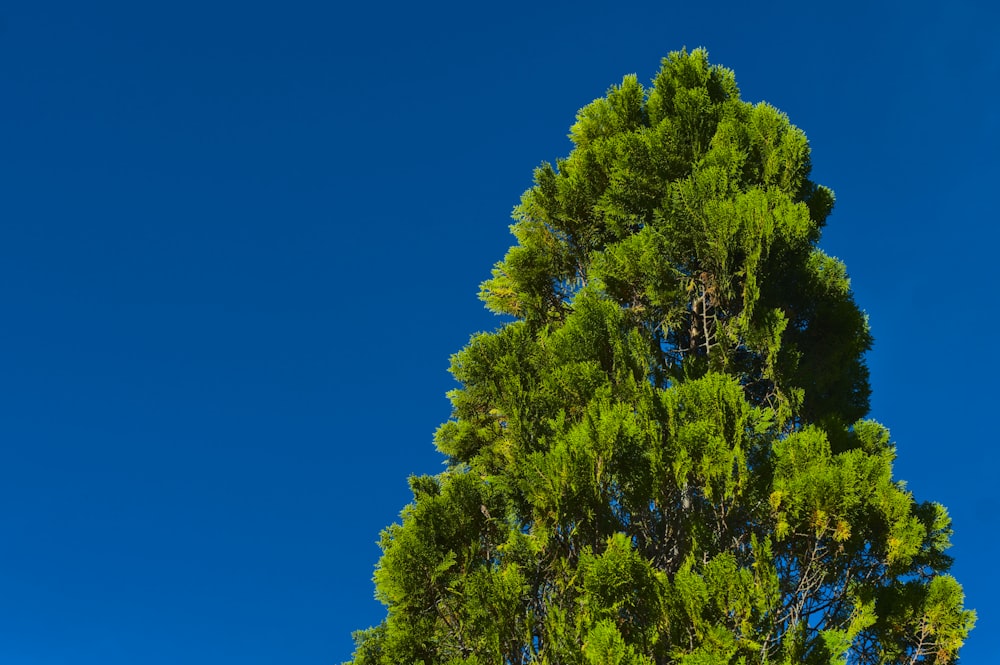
[{"xmin": 0, "ymin": 0, "xmax": 1000, "ymax": 665}]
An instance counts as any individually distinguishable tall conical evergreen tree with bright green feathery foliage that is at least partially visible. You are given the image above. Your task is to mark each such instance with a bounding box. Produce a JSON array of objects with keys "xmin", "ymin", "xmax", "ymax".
[{"xmin": 353, "ymin": 50, "xmax": 975, "ymax": 665}]
